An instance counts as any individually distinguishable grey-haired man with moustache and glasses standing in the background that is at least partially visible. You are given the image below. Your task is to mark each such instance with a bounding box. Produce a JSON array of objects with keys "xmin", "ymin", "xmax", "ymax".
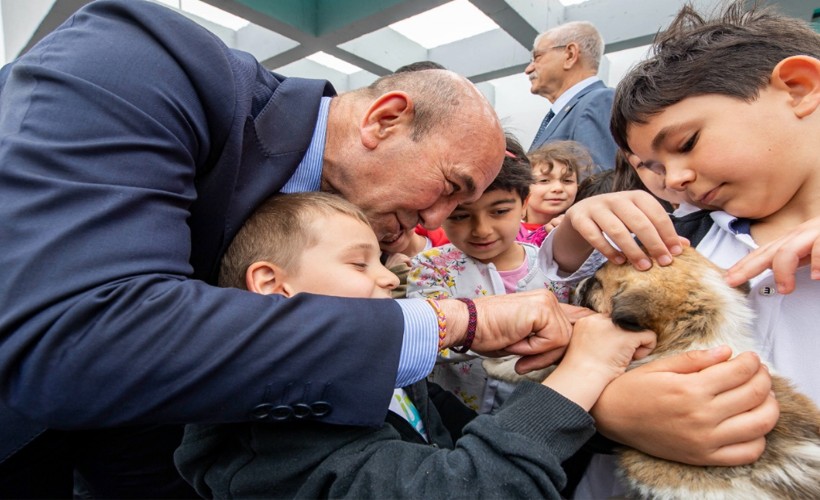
[{"xmin": 524, "ymin": 21, "xmax": 616, "ymax": 173}]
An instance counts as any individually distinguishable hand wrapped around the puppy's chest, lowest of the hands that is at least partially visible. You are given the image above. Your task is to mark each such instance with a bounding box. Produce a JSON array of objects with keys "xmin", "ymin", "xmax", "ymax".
[{"xmin": 591, "ymin": 347, "xmax": 780, "ymax": 466}]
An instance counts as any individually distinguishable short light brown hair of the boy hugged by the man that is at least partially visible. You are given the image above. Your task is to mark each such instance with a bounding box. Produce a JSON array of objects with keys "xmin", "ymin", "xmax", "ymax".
[{"xmin": 219, "ymin": 192, "xmax": 370, "ymax": 290}]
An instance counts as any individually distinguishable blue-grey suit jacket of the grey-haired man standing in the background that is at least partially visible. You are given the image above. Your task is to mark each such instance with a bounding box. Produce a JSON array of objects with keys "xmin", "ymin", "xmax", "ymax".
[{"xmin": 530, "ymin": 81, "xmax": 617, "ymax": 173}]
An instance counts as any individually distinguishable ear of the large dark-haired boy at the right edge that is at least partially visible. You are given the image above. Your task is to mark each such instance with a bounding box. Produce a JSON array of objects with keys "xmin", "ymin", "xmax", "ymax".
[{"xmin": 771, "ymin": 56, "xmax": 820, "ymax": 118}]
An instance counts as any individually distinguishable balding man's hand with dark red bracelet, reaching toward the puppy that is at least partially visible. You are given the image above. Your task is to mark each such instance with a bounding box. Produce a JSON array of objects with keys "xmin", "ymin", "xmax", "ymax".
[{"xmin": 439, "ymin": 289, "xmax": 576, "ymax": 373}]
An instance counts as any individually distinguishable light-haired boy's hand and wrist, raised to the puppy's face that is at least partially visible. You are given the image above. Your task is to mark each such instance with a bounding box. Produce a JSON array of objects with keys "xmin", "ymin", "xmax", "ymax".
[{"xmin": 544, "ymin": 314, "xmax": 656, "ymax": 411}]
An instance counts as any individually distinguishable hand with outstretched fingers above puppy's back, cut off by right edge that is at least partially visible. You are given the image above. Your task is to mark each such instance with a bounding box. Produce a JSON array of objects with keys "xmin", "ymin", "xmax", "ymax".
[{"xmin": 726, "ymin": 217, "xmax": 820, "ymax": 294}]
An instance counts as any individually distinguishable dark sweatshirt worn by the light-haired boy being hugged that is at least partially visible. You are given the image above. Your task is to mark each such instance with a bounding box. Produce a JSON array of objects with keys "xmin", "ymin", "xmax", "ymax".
[{"xmin": 175, "ymin": 382, "xmax": 594, "ymax": 499}]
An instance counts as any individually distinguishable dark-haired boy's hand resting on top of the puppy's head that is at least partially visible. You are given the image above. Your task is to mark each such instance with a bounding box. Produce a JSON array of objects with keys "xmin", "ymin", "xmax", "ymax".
[{"xmin": 555, "ymin": 191, "xmax": 688, "ymax": 270}]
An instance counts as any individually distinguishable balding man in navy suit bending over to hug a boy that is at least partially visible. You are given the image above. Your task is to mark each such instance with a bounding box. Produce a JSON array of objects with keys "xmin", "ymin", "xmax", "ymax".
[{"xmin": 0, "ymin": 0, "xmax": 571, "ymax": 497}]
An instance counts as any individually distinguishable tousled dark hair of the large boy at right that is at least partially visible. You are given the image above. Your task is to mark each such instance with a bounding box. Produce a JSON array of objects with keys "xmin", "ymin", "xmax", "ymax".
[{"xmin": 610, "ymin": 0, "xmax": 820, "ymax": 152}]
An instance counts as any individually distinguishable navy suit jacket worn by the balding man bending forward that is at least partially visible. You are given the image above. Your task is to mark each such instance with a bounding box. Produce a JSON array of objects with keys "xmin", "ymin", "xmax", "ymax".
[{"xmin": 0, "ymin": 0, "xmax": 404, "ymax": 460}]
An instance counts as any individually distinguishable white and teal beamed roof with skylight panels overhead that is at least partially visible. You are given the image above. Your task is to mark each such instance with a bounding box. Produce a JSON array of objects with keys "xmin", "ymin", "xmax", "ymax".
[{"xmin": 0, "ymin": 0, "xmax": 820, "ymax": 145}]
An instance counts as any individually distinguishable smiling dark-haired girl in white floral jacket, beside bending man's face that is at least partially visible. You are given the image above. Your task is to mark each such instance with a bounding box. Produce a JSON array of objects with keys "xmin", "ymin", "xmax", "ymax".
[{"xmin": 407, "ymin": 138, "xmax": 570, "ymax": 413}]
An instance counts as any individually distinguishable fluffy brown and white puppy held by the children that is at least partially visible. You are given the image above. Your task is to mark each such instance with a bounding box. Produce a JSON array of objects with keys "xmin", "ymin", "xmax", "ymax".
[{"xmin": 576, "ymin": 249, "xmax": 820, "ymax": 499}]
